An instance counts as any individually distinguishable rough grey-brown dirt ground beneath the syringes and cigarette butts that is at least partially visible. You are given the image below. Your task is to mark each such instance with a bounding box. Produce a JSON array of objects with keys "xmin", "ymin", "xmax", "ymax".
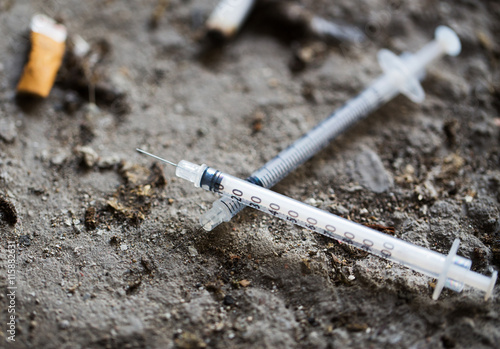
[{"xmin": 0, "ymin": 0, "xmax": 500, "ymax": 348}]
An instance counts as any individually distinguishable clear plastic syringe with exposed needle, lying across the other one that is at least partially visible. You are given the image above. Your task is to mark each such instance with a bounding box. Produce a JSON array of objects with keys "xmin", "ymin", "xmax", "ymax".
[{"xmin": 137, "ymin": 149, "xmax": 497, "ymax": 300}]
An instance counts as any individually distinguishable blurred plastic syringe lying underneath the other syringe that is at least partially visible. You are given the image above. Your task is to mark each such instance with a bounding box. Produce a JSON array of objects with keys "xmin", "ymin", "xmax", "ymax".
[{"xmin": 200, "ymin": 26, "xmax": 461, "ymax": 231}]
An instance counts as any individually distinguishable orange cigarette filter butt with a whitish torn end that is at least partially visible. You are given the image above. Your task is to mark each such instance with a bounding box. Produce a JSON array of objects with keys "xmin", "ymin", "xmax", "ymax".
[{"xmin": 17, "ymin": 14, "xmax": 67, "ymax": 97}]
